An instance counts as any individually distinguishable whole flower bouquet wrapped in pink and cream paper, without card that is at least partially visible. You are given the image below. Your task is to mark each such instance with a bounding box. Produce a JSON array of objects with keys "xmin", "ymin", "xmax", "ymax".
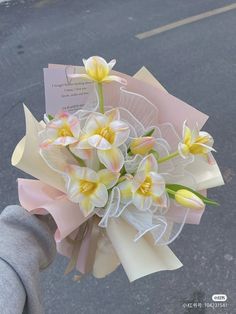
[{"xmin": 12, "ymin": 57, "xmax": 223, "ymax": 281}]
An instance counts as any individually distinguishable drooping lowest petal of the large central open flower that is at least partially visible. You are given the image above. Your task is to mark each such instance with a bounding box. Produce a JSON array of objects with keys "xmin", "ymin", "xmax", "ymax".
[{"xmin": 97, "ymin": 147, "xmax": 124, "ymax": 172}]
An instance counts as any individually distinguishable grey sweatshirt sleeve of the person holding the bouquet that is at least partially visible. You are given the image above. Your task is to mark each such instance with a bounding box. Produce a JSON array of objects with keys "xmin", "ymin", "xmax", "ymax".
[{"xmin": 0, "ymin": 205, "xmax": 56, "ymax": 314}]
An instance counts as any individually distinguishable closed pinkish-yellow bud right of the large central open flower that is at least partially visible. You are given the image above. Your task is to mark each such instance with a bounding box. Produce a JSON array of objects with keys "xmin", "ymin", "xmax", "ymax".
[{"xmin": 130, "ymin": 136, "xmax": 155, "ymax": 155}]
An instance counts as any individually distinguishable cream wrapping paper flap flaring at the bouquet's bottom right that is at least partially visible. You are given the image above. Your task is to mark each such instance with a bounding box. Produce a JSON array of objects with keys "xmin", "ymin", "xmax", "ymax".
[{"xmin": 107, "ymin": 218, "xmax": 183, "ymax": 282}]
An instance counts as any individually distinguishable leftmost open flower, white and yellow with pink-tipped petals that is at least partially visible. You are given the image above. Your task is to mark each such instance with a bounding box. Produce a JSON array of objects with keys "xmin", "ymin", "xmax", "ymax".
[{"xmin": 40, "ymin": 112, "xmax": 80, "ymax": 149}]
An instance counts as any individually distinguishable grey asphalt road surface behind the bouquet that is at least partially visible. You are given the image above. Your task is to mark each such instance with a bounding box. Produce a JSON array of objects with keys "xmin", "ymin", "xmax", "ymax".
[{"xmin": 0, "ymin": 0, "xmax": 236, "ymax": 314}]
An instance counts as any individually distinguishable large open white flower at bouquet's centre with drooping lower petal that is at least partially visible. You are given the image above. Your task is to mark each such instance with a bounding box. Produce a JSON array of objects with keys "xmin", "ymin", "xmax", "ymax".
[{"xmin": 71, "ymin": 109, "xmax": 130, "ymax": 172}]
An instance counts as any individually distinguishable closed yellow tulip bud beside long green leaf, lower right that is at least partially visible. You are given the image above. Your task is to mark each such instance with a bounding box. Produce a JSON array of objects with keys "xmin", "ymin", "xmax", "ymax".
[{"xmin": 175, "ymin": 189, "xmax": 205, "ymax": 209}]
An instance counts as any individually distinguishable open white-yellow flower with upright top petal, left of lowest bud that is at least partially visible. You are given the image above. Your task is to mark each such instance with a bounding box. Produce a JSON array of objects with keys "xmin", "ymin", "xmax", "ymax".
[{"xmin": 118, "ymin": 154, "xmax": 167, "ymax": 210}]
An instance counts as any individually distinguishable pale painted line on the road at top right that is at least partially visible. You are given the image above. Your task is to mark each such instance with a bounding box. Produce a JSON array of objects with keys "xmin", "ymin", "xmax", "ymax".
[{"xmin": 135, "ymin": 3, "xmax": 236, "ymax": 39}]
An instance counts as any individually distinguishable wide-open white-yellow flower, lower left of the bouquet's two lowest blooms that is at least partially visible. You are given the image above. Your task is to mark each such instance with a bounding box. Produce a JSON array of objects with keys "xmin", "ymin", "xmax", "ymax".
[{"xmin": 65, "ymin": 165, "xmax": 120, "ymax": 216}]
